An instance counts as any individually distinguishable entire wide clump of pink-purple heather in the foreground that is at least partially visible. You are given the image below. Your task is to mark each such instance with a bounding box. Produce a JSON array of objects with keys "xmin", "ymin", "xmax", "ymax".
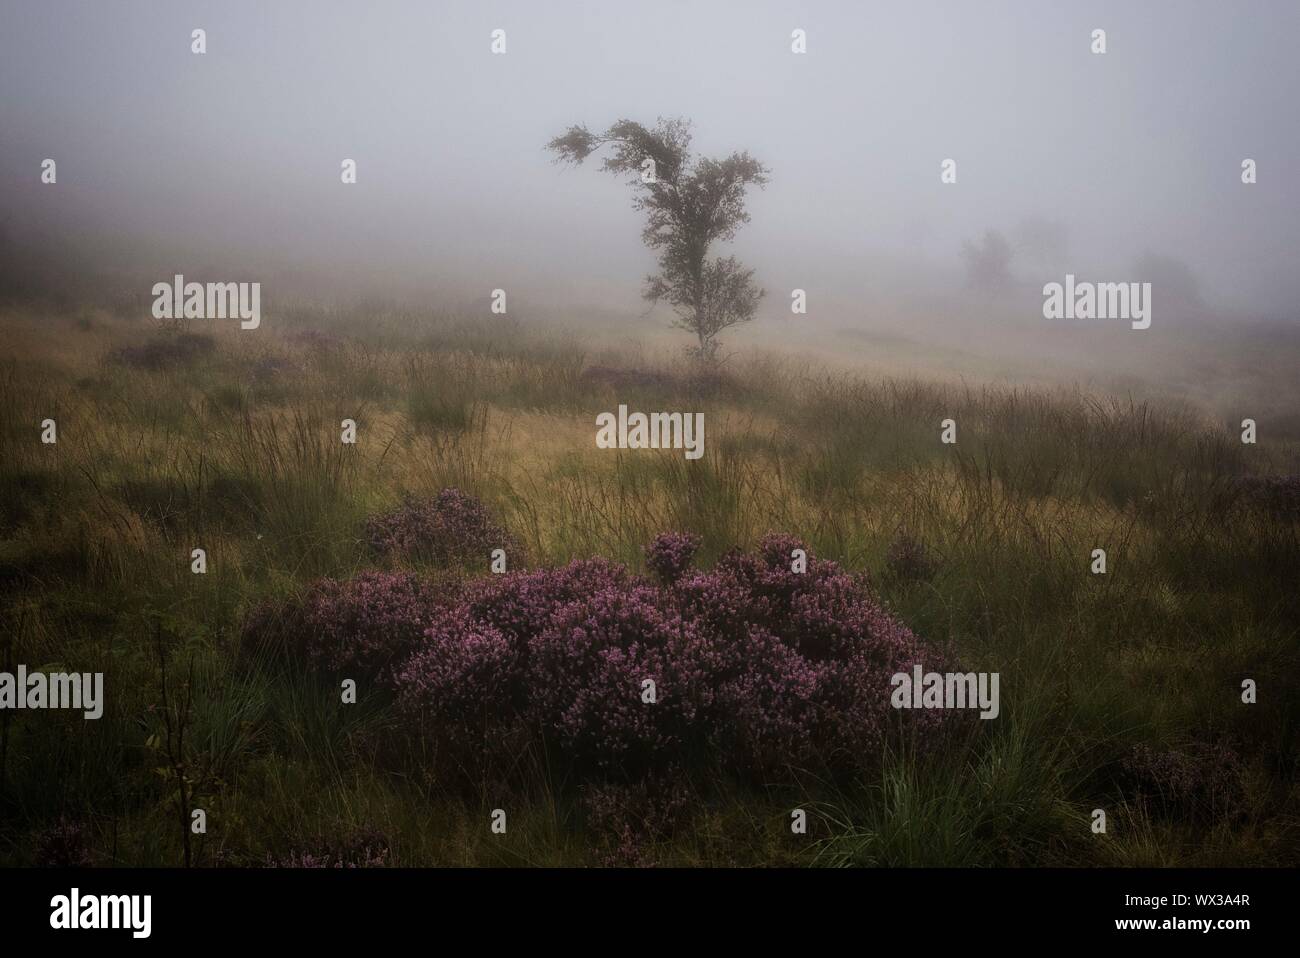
[{"xmin": 233, "ymin": 533, "xmax": 953, "ymax": 805}]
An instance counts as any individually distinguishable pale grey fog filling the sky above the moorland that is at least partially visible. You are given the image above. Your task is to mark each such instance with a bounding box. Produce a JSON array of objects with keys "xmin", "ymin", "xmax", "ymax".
[{"xmin": 0, "ymin": 0, "xmax": 1300, "ymax": 328}]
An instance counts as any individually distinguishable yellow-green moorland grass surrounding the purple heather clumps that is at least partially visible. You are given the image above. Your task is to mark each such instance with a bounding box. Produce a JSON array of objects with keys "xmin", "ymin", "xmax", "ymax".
[{"xmin": 0, "ymin": 302, "xmax": 1300, "ymax": 866}]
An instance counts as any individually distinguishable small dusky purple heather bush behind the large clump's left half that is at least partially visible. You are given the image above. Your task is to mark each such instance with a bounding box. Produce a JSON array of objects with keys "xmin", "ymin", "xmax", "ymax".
[{"xmin": 365, "ymin": 489, "xmax": 520, "ymax": 565}]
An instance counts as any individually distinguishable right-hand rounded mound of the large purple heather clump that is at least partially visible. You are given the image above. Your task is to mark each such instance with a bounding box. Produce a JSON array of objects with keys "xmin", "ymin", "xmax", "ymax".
[{"xmin": 679, "ymin": 536, "xmax": 949, "ymax": 772}]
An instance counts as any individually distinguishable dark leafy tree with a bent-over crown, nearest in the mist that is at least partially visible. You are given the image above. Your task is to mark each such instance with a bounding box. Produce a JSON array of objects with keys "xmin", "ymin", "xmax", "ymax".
[{"xmin": 546, "ymin": 118, "xmax": 768, "ymax": 360}]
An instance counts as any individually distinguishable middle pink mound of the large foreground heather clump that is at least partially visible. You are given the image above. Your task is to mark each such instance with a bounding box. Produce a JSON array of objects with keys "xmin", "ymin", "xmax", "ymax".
[{"xmin": 398, "ymin": 559, "xmax": 677, "ymax": 772}]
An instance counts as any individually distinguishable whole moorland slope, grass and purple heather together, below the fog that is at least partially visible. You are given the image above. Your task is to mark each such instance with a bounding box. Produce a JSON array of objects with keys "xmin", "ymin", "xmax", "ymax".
[{"xmin": 0, "ymin": 299, "xmax": 1300, "ymax": 867}]
